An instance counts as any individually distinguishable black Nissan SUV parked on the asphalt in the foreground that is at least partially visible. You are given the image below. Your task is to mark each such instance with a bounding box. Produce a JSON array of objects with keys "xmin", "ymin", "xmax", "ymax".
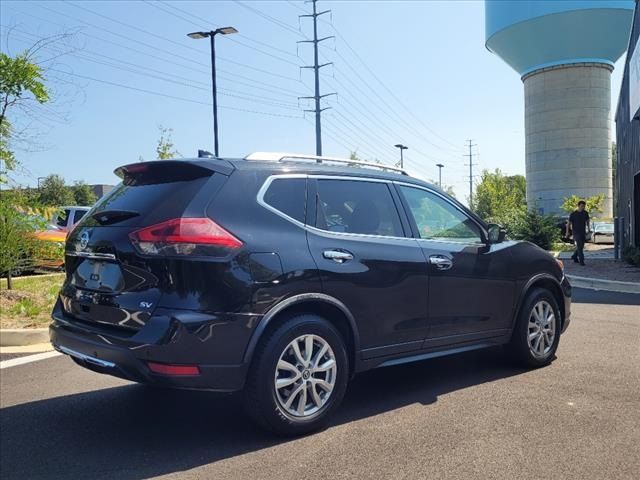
[{"xmin": 50, "ymin": 154, "xmax": 571, "ymax": 434}]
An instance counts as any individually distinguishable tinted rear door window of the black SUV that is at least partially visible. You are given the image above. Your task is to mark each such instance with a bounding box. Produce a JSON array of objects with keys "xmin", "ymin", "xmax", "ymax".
[{"xmin": 316, "ymin": 180, "xmax": 404, "ymax": 237}]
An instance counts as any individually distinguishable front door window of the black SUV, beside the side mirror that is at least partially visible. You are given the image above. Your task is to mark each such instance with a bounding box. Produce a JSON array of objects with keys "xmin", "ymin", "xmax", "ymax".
[{"xmin": 400, "ymin": 186, "xmax": 482, "ymax": 243}]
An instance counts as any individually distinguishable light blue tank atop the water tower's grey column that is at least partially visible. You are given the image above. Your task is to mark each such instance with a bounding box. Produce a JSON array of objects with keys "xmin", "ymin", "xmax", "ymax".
[{"xmin": 485, "ymin": 0, "xmax": 635, "ymax": 75}]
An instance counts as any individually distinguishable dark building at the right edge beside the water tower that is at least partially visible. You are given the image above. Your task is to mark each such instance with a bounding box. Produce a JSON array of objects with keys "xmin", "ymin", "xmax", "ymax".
[{"xmin": 615, "ymin": 0, "xmax": 640, "ymax": 247}]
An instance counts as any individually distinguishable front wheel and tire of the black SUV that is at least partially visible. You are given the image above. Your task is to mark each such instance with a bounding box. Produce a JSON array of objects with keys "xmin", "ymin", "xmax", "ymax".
[{"xmin": 509, "ymin": 288, "xmax": 562, "ymax": 368}]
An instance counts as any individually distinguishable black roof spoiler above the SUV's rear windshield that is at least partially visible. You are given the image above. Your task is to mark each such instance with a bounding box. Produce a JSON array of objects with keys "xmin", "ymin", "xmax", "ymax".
[{"xmin": 113, "ymin": 158, "xmax": 234, "ymax": 183}]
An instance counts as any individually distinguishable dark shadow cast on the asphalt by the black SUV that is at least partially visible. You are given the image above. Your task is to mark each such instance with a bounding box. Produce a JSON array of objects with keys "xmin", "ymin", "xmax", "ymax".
[{"xmin": 0, "ymin": 349, "xmax": 525, "ymax": 480}]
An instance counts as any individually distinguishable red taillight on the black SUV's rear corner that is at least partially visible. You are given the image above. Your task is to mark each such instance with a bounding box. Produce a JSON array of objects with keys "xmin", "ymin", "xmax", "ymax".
[{"xmin": 129, "ymin": 218, "xmax": 242, "ymax": 255}]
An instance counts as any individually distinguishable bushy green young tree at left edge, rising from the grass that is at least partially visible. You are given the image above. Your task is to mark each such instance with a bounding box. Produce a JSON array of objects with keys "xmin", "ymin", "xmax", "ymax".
[{"xmin": 0, "ymin": 192, "xmax": 39, "ymax": 290}]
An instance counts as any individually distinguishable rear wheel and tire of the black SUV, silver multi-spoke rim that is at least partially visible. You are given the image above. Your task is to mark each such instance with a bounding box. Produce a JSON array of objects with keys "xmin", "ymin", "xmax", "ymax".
[{"xmin": 244, "ymin": 314, "xmax": 349, "ymax": 436}]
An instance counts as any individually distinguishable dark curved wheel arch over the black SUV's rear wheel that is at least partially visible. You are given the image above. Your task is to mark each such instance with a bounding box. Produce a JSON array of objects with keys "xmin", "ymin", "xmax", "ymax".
[{"xmin": 244, "ymin": 293, "xmax": 360, "ymax": 374}]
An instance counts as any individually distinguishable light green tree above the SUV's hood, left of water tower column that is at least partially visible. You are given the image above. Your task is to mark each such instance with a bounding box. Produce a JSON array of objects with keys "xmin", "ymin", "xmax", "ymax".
[{"xmin": 474, "ymin": 168, "xmax": 527, "ymax": 223}]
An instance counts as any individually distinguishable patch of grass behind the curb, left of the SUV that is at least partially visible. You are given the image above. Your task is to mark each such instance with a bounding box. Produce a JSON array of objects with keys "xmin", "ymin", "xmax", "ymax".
[{"xmin": 0, "ymin": 273, "xmax": 64, "ymax": 328}]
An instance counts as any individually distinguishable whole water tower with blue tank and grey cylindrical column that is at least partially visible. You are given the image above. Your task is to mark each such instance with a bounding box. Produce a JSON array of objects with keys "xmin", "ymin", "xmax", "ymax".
[{"xmin": 485, "ymin": 0, "xmax": 634, "ymax": 217}]
